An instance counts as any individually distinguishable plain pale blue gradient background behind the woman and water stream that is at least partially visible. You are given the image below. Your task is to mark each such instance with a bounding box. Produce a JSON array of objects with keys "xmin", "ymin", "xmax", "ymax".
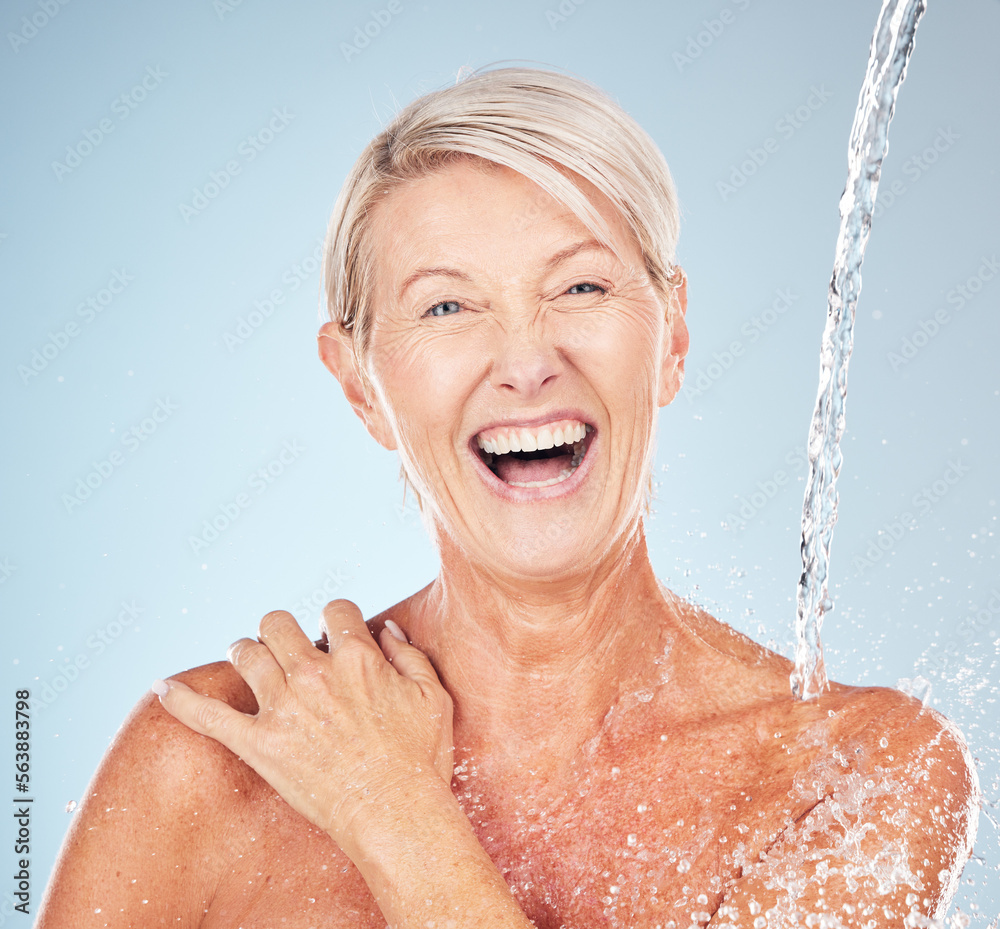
[{"xmin": 0, "ymin": 0, "xmax": 1000, "ymax": 927}]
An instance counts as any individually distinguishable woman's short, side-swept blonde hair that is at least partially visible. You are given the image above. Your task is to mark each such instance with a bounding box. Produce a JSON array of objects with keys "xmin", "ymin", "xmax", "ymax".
[{"xmin": 323, "ymin": 68, "xmax": 680, "ymax": 382}]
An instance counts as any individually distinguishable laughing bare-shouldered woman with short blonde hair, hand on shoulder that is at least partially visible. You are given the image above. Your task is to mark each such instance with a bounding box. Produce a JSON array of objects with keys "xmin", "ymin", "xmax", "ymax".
[{"xmin": 40, "ymin": 69, "xmax": 977, "ymax": 929}]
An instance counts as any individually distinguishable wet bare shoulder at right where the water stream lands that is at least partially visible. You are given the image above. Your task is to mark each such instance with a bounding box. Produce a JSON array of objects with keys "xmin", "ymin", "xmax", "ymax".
[{"xmin": 720, "ymin": 684, "xmax": 979, "ymax": 927}]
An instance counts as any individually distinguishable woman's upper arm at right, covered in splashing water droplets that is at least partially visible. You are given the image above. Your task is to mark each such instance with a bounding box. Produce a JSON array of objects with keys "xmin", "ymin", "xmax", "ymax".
[{"xmin": 709, "ymin": 691, "xmax": 978, "ymax": 929}]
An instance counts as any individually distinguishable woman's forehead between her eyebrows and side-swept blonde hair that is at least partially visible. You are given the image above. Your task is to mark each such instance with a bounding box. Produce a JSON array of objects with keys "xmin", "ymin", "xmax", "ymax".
[{"xmin": 369, "ymin": 158, "xmax": 641, "ymax": 283}]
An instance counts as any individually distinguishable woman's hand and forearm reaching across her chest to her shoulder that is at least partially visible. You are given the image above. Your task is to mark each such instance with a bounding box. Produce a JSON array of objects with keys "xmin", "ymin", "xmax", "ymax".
[{"xmin": 155, "ymin": 600, "xmax": 533, "ymax": 929}]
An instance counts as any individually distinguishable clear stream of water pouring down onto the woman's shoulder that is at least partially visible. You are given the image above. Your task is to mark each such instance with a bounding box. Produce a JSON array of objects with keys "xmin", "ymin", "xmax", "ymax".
[{"xmin": 791, "ymin": 0, "xmax": 927, "ymax": 700}]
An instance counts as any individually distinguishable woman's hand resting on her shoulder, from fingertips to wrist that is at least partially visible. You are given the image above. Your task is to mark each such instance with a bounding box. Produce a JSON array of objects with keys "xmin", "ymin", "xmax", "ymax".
[{"xmin": 154, "ymin": 600, "xmax": 453, "ymax": 858}]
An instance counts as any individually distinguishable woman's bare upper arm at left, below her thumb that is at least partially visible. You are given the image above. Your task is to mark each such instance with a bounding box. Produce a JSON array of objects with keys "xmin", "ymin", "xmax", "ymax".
[{"xmin": 37, "ymin": 666, "xmax": 256, "ymax": 929}]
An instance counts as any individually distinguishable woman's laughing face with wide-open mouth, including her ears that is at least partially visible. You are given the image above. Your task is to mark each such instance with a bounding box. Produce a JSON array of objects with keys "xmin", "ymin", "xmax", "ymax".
[{"xmin": 320, "ymin": 159, "xmax": 687, "ymax": 578}]
